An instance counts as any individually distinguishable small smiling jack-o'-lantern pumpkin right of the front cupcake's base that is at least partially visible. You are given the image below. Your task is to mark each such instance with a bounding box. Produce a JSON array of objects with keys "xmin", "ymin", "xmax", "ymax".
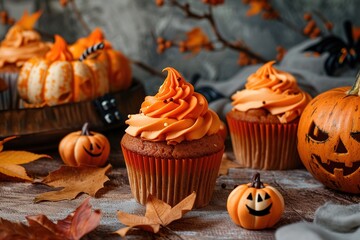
[{"xmin": 226, "ymin": 173, "xmax": 285, "ymax": 230}]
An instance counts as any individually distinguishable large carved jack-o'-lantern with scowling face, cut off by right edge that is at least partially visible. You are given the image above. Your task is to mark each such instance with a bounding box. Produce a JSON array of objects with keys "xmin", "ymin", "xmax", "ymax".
[{"xmin": 298, "ymin": 74, "xmax": 360, "ymax": 194}]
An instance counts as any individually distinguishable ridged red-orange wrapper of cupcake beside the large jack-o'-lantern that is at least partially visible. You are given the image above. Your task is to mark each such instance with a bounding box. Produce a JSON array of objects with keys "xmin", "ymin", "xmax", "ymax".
[{"xmin": 227, "ymin": 116, "xmax": 301, "ymax": 170}]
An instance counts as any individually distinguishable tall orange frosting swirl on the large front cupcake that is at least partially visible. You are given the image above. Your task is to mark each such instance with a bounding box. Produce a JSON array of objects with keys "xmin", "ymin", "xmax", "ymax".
[{"xmin": 125, "ymin": 67, "xmax": 220, "ymax": 144}]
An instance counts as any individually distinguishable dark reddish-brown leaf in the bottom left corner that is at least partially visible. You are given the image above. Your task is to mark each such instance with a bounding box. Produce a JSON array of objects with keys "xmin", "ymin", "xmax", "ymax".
[{"xmin": 0, "ymin": 198, "xmax": 101, "ymax": 240}]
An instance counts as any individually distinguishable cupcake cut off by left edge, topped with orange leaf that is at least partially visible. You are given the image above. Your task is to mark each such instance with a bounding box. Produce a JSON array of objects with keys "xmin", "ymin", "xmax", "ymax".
[{"xmin": 0, "ymin": 12, "xmax": 51, "ymax": 110}]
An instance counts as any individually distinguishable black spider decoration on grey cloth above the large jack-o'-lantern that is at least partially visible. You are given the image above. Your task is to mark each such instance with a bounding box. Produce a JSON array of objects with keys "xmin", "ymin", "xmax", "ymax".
[{"xmin": 304, "ymin": 21, "xmax": 360, "ymax": 75}]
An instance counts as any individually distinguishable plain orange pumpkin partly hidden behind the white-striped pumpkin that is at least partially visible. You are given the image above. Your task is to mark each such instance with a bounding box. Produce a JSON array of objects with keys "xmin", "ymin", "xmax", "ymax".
[{"xmin": 69, "ymin": 28, "xmax": 132, "ymax": 92}]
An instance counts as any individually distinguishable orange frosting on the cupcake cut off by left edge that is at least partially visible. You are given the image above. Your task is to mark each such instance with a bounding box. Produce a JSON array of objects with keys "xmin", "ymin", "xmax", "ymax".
[{"xmin": 0, "ymin": 25, "xmax": 51, "ymax": 67}]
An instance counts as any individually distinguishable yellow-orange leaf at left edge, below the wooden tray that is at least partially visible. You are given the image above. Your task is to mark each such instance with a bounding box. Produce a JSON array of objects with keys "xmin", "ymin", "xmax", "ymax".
[{"xmin": 0, "ymin": 137, "xmax": 50, "ymax": 181}]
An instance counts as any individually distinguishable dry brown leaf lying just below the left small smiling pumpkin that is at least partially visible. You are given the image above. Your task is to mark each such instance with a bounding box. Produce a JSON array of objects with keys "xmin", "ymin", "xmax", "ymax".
[{"xmin": 34, "ymin": 164, "xmax": 111, "ymax": 202}]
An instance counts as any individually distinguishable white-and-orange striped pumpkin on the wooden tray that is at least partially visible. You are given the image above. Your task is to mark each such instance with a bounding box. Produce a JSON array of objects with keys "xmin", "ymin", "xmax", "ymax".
[{"xmin": 18, "ymin": 35, "xmax": 109, "ymax": 107}]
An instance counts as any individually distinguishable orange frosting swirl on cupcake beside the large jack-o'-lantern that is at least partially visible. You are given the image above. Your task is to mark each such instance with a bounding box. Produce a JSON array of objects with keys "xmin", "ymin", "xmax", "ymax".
[{"xmin": 231, "ymin": 61, "xmax": 311, "ymax": 123}]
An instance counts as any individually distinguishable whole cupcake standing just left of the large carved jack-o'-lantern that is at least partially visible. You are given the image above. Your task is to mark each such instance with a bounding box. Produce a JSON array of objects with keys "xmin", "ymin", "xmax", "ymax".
[{"xmin": 226, "ymin": 61, "xmax": 311, "ymax": 170}]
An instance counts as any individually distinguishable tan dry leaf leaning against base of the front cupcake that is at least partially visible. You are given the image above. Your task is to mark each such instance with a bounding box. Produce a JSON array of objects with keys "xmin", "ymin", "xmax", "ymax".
[{"xmin": 115, "ymin": 192, "xmax": 196, "ymax": 237}]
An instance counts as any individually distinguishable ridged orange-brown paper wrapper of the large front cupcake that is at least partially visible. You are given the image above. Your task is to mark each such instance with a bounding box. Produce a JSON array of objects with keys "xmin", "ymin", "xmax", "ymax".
[{"xmin": 122, "ymin": 147, "xmax": 224, "ymax": 208}]
